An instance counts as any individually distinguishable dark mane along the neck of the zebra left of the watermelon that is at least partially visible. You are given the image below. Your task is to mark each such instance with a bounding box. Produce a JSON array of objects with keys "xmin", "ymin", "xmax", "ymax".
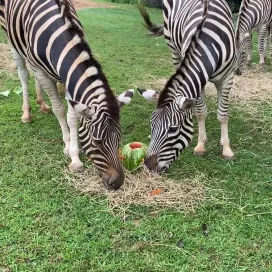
[{"xmin": 55, "ymin": 0, "xmax": 119, "ymax": 121}]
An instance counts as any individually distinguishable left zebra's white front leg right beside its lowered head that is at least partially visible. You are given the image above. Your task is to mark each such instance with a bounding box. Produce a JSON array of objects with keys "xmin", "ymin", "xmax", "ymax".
[{"xmin": 67, "ymin": 102, "xmax": 83, "ymax": 172}]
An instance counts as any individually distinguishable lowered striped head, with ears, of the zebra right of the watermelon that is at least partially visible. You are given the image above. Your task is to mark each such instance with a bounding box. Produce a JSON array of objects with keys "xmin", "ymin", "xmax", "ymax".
[{"xmin": 138, "ymin": 89, "xmax": 196, "ymax": 173}]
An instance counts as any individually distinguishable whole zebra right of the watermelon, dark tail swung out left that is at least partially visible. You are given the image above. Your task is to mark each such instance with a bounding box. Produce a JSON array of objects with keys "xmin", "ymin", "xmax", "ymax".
[{"xmin": 140, "ymin": 0, "xmax": 236, "ymax": 172}]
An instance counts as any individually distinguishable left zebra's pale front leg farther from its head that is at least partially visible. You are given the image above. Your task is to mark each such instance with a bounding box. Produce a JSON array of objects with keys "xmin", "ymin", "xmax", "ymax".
[{"xmin": 35, "ymin": 70, "xmax": 70, "ymax": 156}]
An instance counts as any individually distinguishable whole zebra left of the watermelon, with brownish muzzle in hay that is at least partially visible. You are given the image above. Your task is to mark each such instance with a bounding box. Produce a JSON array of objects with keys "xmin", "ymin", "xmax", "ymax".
[{"xmin": 0, "ymin": 0, "xmax": 133, "ymax": 189}]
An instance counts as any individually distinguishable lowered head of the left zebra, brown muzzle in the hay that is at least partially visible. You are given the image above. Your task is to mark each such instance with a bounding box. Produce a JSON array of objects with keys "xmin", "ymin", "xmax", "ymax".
[{"xmin": 75, "ymin": 90, "xmax": 133, "ymax": 190}]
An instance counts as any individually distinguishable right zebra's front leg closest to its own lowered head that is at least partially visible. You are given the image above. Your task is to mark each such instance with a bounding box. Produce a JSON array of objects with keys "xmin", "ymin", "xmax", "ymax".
[{"xmin": 194, "ymin": 89, "xmax": 207, "ymax": 156}]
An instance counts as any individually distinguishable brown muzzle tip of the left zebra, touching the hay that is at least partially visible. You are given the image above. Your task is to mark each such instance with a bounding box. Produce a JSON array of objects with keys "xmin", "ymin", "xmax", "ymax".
[{"xmin": 102, "ymin": 166, "xmax": 125, "ymax": 190}]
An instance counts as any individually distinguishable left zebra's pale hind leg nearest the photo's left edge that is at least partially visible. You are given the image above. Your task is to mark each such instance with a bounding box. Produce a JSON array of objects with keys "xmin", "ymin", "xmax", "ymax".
[{"xmin": 11, "ymin": 48, "xmax": 32, "ymax": 123}]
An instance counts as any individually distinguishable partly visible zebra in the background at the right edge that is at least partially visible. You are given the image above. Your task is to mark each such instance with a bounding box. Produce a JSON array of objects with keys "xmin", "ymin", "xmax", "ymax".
[{"xmin": 235, "ymin": 0, "xmax": 272, "ymax": 75}]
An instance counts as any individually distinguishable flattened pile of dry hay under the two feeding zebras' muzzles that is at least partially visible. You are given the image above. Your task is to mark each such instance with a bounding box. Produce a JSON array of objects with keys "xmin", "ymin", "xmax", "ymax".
[{"xmin": 65, "ymin": 167, "xmax": 205, "ymax": 212}]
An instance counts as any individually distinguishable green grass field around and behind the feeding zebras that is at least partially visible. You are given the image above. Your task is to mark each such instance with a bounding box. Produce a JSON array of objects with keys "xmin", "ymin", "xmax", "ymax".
[{"xmin": 0, "ymin": 2, "xmax": 272, "ymax": 272}]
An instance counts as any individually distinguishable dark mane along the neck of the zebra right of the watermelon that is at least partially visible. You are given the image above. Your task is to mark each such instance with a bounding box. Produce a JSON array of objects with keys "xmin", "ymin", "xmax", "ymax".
[{"xmin": 158, "ymin": 0, "xmax": 209, "ymax": 107}]
